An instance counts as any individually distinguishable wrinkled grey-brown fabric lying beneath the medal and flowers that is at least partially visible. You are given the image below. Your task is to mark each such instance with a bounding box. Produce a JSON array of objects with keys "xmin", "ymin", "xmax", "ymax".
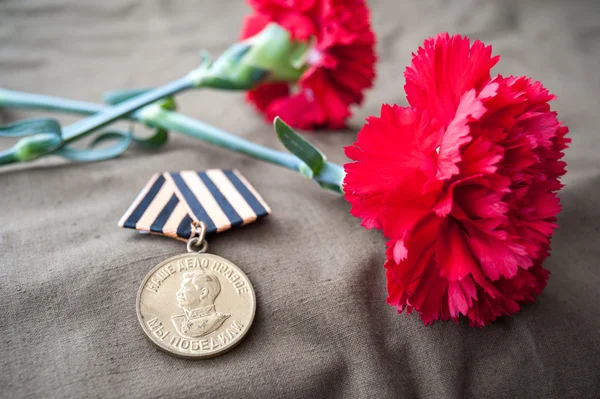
[{"xmin": 0, "ymin": 0, "xmax": 600, "ymax": 398}]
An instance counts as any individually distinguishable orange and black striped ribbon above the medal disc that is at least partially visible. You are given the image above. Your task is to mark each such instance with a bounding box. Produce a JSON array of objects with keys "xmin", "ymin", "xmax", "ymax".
[{"xmin": 119, "ymin": 169, "xmax": 271, "ymax": 239}]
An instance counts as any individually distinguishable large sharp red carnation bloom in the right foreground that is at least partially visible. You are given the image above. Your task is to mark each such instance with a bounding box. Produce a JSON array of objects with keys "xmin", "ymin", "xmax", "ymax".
[{"xmin": 344, "ymin": 34, "xmax": 570, "ymax": 326}]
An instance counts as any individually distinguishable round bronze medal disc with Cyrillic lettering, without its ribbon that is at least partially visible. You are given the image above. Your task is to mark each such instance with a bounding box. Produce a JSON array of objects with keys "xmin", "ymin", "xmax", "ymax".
[{"xmin": 137, "ymin": 253, "xmax": 256, "ymax": 359}]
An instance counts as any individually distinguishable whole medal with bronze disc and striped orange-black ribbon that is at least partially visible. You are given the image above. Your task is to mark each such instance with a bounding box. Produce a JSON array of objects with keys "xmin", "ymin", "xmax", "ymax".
[{"xmin": 119, "ymin": 170, "xmax": 270, "ymax": 359}]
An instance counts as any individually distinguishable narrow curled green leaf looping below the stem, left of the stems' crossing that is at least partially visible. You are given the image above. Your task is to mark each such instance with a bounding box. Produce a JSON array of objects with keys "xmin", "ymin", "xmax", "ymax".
[{"xmin": 56, "ymin": 130, "xmax": 133, "ymax": 162}]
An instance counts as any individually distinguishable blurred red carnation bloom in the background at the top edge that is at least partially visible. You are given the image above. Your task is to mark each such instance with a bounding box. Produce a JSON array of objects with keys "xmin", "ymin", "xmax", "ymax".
[{"xmin": 241, "ymin": 0, "xmax": 376, "ymax": 129}]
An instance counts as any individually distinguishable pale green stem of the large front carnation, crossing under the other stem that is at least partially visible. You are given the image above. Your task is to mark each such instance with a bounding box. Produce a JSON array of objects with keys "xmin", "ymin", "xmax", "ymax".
[{"xmin": 0, "ymin": 89, "xmax": 344, "ymax": 192}]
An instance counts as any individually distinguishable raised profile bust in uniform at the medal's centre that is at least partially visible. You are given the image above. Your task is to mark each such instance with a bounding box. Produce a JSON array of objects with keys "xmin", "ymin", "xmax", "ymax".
[{"xmin": 171, "ymin": 270, "xmax": 230, "ymax": 338}]
